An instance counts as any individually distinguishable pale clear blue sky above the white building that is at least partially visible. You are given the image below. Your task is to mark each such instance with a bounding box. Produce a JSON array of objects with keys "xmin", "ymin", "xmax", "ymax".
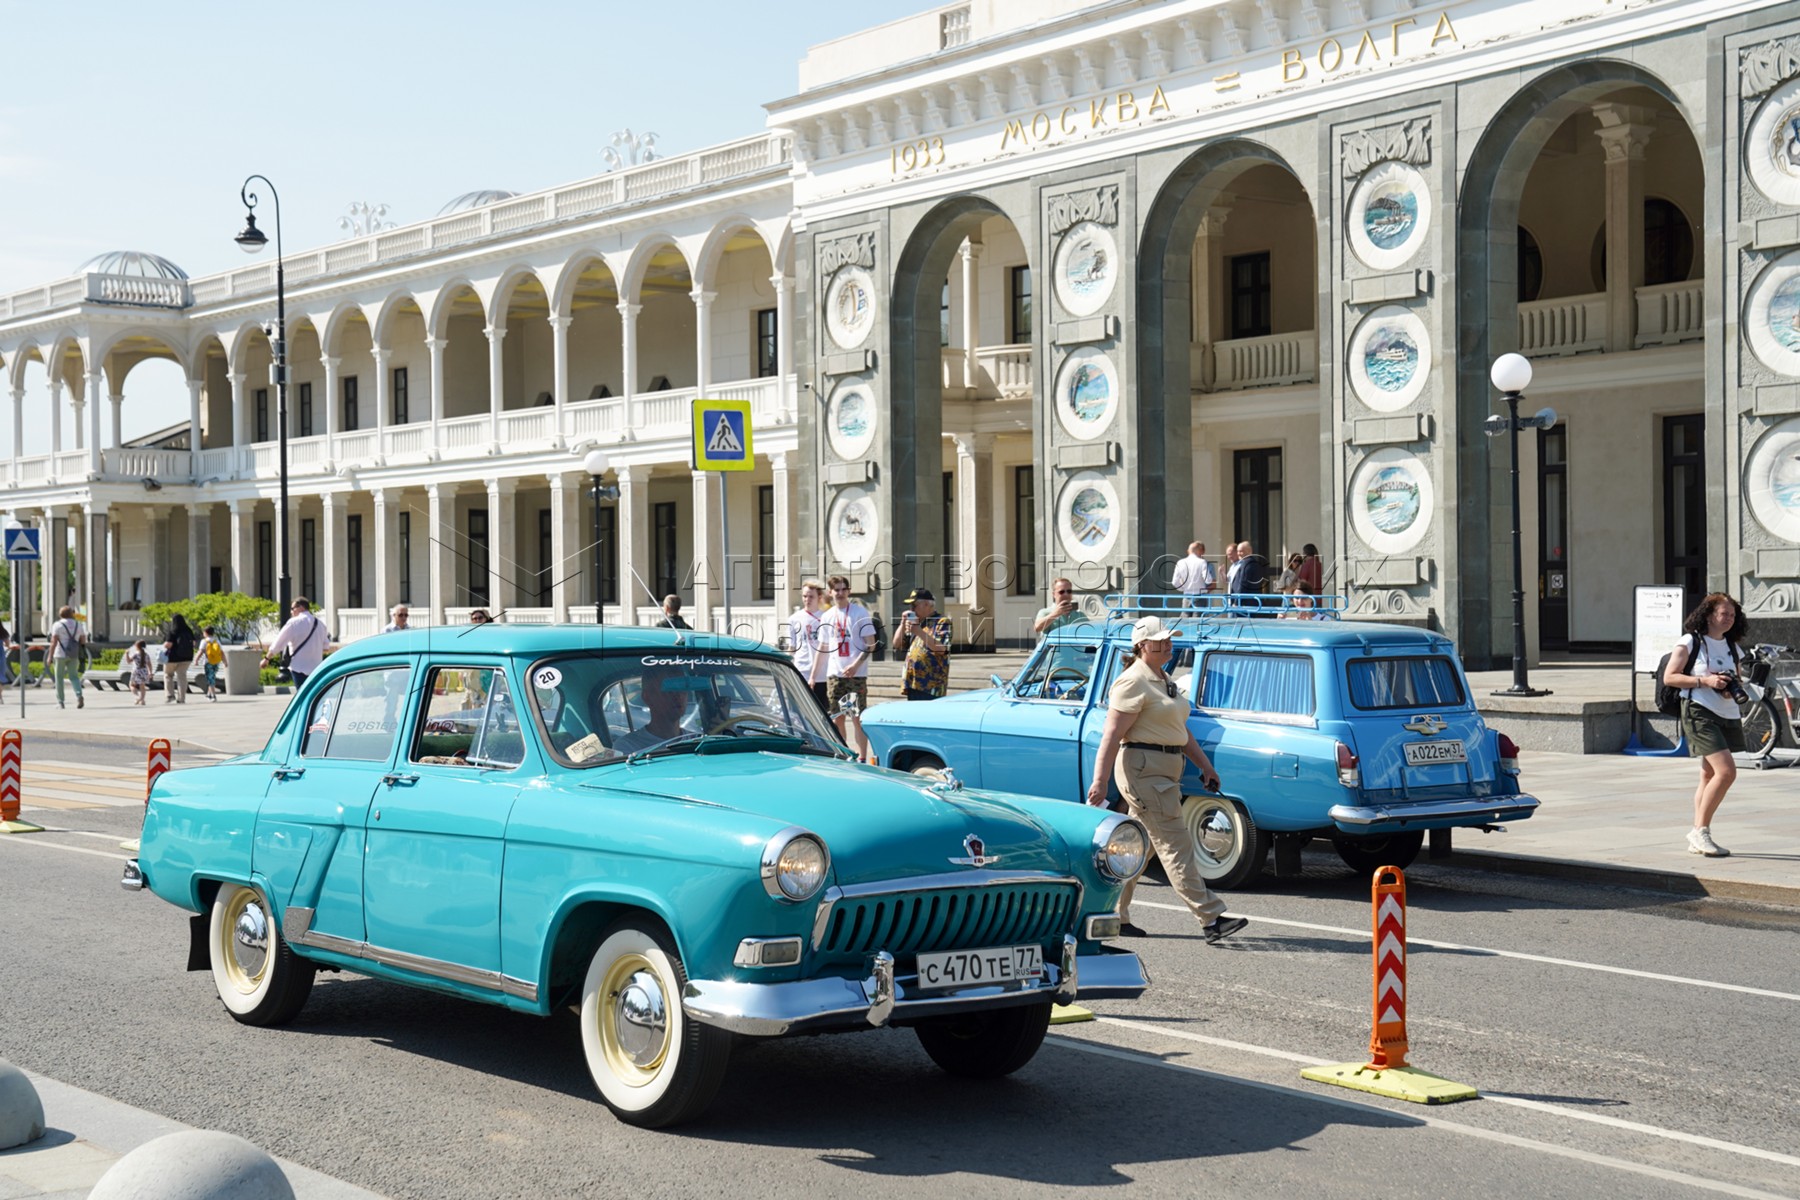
[{"xmin": 0, "ymin": 0, "xmax": 932, "ymax": 455}]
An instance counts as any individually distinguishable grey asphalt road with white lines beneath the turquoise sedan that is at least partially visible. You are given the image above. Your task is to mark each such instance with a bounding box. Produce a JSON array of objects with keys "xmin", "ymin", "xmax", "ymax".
[{"xmin": 0, "ymin": 788, "xmax": 1800, "ymax": 1198}]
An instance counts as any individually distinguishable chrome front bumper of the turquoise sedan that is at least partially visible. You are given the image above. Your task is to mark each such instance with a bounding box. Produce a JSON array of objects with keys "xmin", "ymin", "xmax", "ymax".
[{"xmin": 682, "ymin": 937, "xmax": 1150, "ymax": 1038}]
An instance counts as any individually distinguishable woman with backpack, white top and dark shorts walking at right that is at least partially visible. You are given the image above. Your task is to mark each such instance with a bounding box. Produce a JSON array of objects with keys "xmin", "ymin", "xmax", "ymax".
[{"xmin": 1663, "ymin": 592, "xmax": 1750, "ymax": 858}]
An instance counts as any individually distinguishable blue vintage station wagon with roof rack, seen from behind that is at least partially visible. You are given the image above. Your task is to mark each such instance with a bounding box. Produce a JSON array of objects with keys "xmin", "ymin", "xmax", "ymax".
[{"xmin": 862, "ymin": 596, "xmax": 1537, "ymax": 887}]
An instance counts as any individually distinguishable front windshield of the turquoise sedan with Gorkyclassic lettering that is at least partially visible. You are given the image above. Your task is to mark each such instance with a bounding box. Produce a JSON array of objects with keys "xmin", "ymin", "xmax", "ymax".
[{"xmin": 531, "ymin": 649, "xmax": 842, "ymax": 766}]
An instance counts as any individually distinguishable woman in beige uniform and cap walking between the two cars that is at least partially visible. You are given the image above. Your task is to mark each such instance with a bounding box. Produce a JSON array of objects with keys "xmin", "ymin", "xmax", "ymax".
[{"xmin": 1087, "ymin": 617, "xmax": 1249, "ymax": 943}]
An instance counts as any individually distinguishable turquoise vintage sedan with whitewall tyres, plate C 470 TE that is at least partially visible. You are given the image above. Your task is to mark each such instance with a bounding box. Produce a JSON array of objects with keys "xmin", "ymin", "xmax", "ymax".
[{"xmin": 124, "ymin": 624, "xmax": 1148, "ymax": 1126}]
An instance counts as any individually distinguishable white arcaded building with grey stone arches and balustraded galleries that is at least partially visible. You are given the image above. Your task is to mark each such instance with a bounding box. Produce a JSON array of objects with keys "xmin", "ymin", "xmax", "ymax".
[{"xmin": 0, "ymin": 0, "xmax": 1800, "ymax": 666}]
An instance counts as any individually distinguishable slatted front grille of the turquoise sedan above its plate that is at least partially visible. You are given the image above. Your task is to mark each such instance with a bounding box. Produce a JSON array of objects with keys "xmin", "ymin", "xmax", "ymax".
[{"xmin": 814, "ymin": 882, "xmax": 1078, "ymax": 955}]
